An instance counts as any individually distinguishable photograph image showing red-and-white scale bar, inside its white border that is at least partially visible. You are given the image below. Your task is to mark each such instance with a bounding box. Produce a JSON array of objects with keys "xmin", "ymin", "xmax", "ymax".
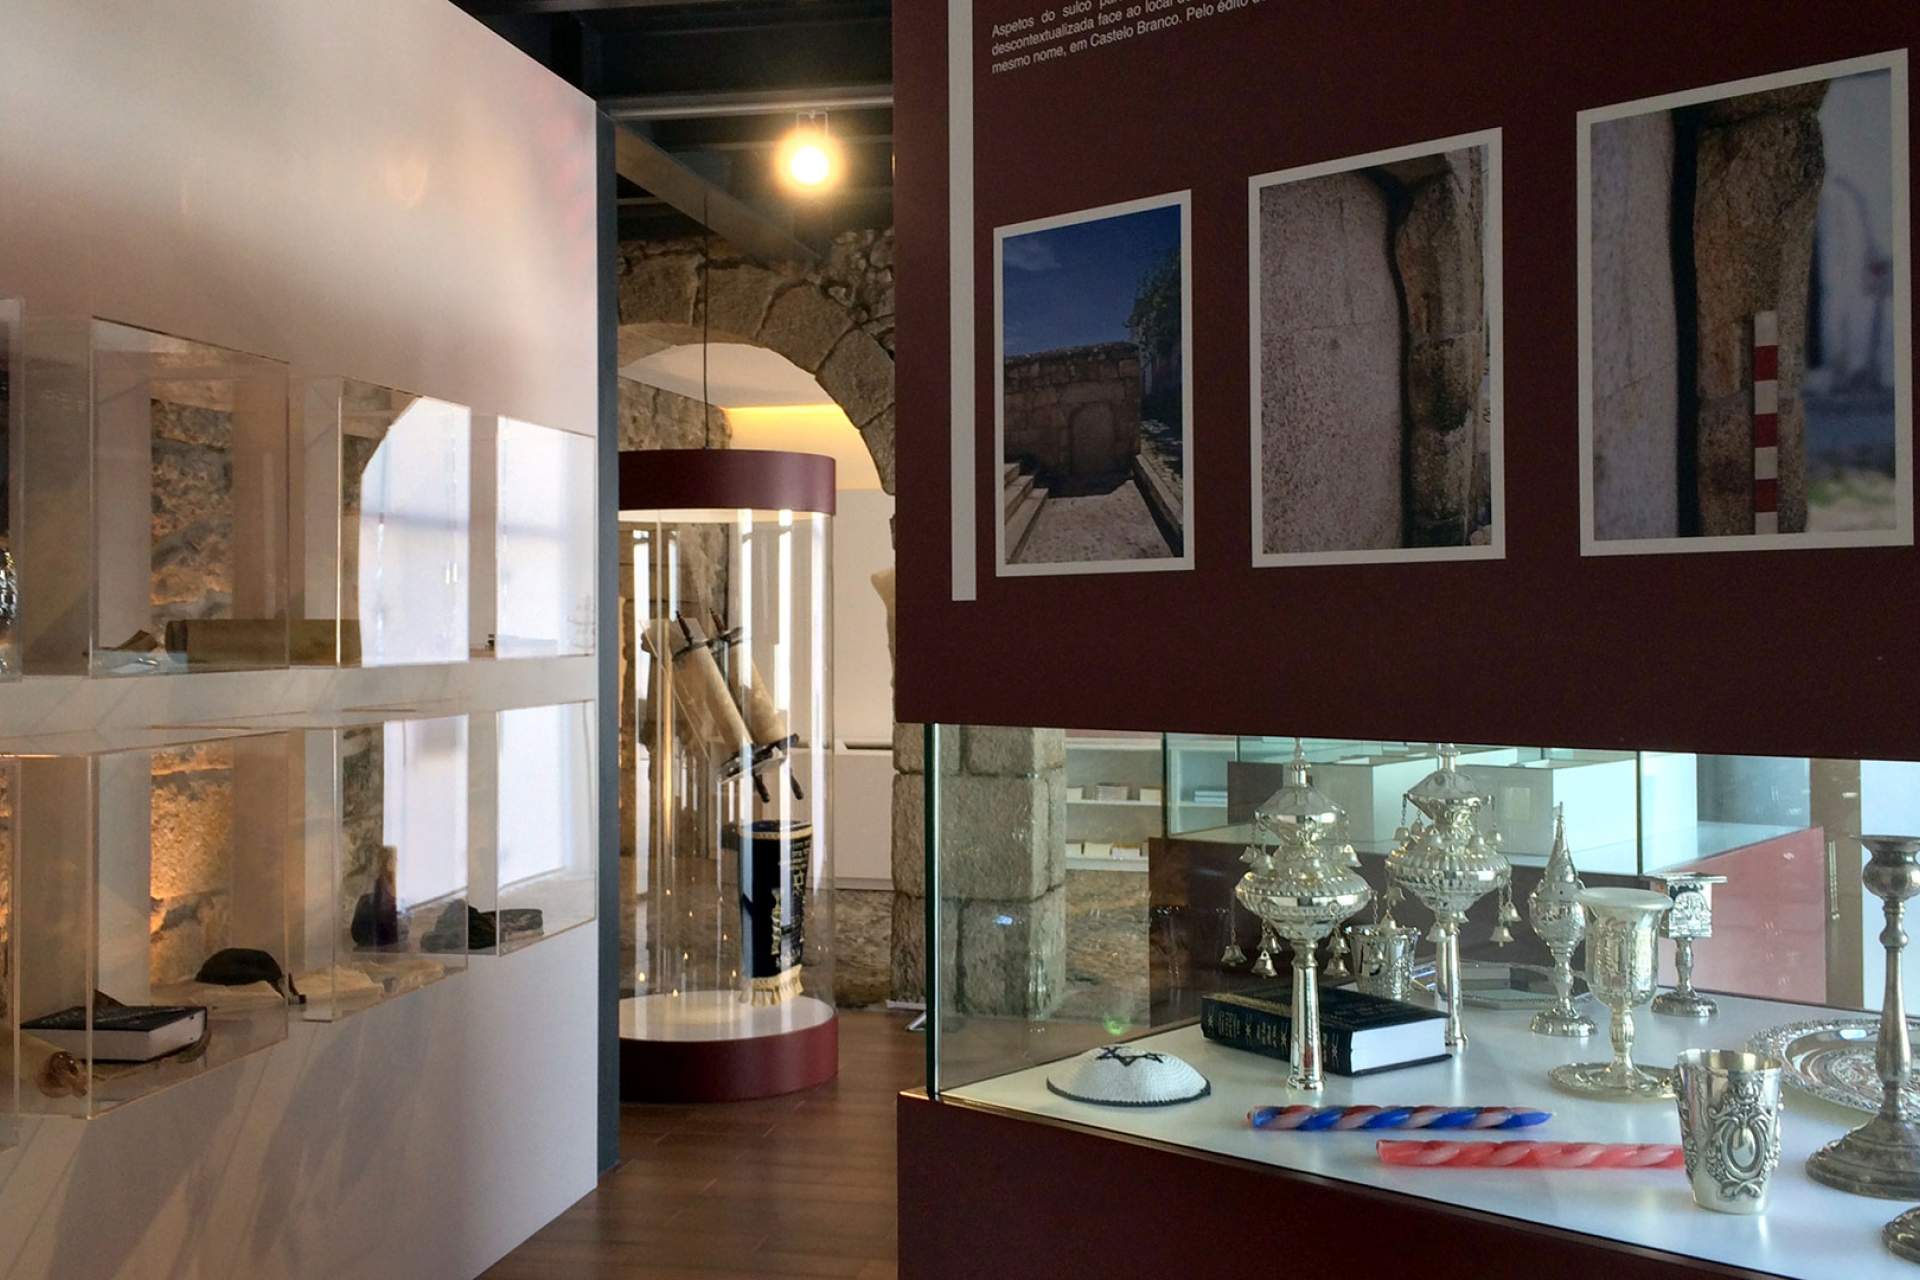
[{"xmin": 1588, "ymin": 62, "xmax": 1910, "ymax": 541}]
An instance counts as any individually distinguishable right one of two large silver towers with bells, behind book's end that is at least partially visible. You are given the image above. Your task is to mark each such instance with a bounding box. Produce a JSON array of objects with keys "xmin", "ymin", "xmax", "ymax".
[{"xmin": 1386, "ymin": 743, "xmax": 1513, "ymax": 1050}]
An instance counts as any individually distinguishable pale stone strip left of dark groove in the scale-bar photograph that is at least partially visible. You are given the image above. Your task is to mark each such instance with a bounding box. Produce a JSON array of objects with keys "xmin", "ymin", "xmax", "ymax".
[{"xmin": 1592, "ymin": 111, "xmax": 1680, "ymax": 537}]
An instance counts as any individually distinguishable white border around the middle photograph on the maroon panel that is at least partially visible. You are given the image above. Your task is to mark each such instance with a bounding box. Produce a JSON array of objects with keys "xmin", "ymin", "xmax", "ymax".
[{"xmin": 1246, "ymin": 129, "xmax": 1507, "ymax": 568}]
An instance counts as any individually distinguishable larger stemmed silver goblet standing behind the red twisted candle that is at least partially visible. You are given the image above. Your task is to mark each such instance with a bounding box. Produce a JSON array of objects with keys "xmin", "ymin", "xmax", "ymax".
[{"xmin": 1549, "ymin": 889, "xmax": 1674, "ymax": 1102}]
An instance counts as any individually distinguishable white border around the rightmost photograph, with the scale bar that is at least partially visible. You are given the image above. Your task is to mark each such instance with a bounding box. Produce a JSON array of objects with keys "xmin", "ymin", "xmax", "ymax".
[{"xmin": 1574, "ymin": 50, "xmax": 1914, "ymax": 557}]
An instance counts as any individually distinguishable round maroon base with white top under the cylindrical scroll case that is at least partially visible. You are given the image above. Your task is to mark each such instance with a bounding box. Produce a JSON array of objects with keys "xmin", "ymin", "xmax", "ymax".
[{"xmin": 620, "ymin": 990, "xmax": 839, "ymax": 1102}]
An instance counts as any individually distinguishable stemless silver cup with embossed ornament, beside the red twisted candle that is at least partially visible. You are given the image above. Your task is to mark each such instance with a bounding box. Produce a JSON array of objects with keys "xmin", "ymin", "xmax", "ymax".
[{"xmin": 1674, "ymin": 1050, "xmax": 1784, "ymax": 1213}]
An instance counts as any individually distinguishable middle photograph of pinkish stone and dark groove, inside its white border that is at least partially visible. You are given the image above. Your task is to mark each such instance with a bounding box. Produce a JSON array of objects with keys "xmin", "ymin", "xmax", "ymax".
[{"xmin": 1252, "ymin": 144, "xmax": 1500, "ymax": 562}]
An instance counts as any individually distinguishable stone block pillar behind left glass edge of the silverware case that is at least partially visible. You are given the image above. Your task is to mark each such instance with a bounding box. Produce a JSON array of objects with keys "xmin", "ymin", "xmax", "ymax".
[{"xmin": 893, "ymin": 725, "xmax": 1066, "ymax": 1017}]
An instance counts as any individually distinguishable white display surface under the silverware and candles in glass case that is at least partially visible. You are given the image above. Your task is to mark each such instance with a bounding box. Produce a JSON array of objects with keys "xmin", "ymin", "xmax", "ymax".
[{"xmin": 943, "ymin": 996, "xmax": 1914, "ymax": 1280}]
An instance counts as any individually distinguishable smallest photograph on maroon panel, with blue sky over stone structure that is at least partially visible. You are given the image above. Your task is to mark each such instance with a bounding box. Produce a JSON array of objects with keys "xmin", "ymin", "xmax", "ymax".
[{"xmin": 1000, "ymin": 203, "xmax": 1187, "ymax": 572}]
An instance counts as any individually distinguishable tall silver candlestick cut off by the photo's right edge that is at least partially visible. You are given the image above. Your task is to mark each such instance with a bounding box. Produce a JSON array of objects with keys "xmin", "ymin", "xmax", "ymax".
[{"xmin": 1807, "ymin": 835, "xmax": 1920, "ymax": 1199}]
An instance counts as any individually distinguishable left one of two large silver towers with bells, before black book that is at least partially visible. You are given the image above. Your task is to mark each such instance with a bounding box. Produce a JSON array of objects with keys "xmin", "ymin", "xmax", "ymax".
[{"xmin": 1233, "ymin": 741, "xmax": 1373, "ymax": 1090}]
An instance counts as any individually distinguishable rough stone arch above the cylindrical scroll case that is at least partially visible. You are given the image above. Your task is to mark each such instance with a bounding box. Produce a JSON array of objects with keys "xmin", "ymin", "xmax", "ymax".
[{"xmin": 620, "ymin": 234, "xmax": 895, "ymax": 493}]
